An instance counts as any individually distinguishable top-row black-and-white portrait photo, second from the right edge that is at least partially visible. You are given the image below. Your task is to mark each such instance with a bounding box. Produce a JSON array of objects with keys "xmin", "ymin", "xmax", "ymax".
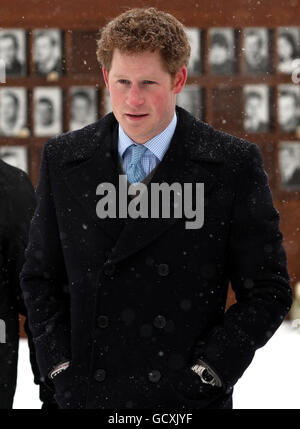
[{"xmin": 244, "ymin": 28, "xmax": 270, "ymax": 74}]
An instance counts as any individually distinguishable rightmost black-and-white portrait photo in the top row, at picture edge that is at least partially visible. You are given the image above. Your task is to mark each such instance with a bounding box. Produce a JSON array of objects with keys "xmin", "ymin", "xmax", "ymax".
[{"xmin": 277, "ymin": 27, "xmax": 300, "ymax": 73}]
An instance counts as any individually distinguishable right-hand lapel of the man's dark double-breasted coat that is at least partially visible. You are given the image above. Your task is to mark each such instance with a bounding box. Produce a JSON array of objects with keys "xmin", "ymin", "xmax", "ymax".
[{"xmin": 110, "ymin": 106, "xmax": 222, "ymax": 262}]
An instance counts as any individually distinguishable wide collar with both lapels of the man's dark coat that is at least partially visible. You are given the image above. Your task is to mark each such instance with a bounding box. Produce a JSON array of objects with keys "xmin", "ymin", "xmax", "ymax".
[{"xmin": 64, "ymin": 106, "xmax": 223, "ymax": 262}]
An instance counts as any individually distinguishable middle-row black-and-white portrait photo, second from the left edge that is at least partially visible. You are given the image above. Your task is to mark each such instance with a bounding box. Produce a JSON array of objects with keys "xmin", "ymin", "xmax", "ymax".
[{"xmin": 33, "ymin": 87, "xmax": 63, "ymax": 137}]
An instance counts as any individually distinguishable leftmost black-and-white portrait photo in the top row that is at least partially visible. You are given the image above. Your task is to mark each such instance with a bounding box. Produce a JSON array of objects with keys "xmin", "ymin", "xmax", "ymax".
[{"xmin": 0, "ymin": 29, "xmax": 26, "ymax": 77}]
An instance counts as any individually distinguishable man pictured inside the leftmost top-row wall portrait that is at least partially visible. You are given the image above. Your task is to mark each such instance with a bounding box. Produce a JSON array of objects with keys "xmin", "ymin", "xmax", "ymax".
[{"xmin": 0, "ymin": 33, "xmax": 24, "ymax": 76}]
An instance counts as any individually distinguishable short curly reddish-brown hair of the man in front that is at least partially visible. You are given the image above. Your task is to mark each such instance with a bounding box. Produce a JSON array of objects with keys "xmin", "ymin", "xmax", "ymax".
[{"xmin": 97, "ymin": 7, "xmax": 191, "ymax": 77}]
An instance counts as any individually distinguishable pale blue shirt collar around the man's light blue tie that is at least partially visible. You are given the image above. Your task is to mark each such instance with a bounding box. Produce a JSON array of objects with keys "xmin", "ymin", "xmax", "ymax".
[{"xmin": 118, "ymin": 112, "xmax": 177, "ymax": 161}]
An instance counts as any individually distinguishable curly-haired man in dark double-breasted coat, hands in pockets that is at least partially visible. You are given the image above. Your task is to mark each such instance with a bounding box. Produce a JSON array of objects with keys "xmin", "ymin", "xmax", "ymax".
[{"xmin": 21, "ymin": 8, "xmax": 291, "ymax": 409}]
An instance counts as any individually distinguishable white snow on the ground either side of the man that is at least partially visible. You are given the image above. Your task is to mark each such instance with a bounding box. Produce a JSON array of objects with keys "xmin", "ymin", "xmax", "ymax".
[{"xmin": 14, "ymin": 322, "xmax": 300, "ymax": 409}]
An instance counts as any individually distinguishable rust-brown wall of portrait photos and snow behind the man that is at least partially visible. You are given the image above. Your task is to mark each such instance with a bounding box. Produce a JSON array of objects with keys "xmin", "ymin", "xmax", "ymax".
[{"xmin": 0, "ymin": 0, "xmax": 300, "ymax": 408}]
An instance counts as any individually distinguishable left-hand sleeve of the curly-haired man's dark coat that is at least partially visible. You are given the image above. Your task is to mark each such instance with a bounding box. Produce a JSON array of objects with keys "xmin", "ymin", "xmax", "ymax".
[{"xmin": 20, "ymin": 140, "xmax": 71, "ymax": 379}]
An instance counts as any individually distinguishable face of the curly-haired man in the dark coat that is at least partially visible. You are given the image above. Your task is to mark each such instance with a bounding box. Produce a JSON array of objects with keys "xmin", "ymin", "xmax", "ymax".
[{"xmin": 102, "ymin": 49, "xmax": 187, "ymax": 143}]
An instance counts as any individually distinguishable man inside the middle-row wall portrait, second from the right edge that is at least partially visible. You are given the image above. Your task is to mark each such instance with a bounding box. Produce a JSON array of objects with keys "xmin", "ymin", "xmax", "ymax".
[{"xmin": 244, "ymin": 90, "xmax": 269, "ymax": 133}]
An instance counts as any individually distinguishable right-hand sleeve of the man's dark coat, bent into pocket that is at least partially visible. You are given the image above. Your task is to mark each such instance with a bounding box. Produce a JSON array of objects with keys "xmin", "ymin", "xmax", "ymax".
[{"xmin": 192, "ymin": 144, "xmax": 292, "ymax": 388}]
